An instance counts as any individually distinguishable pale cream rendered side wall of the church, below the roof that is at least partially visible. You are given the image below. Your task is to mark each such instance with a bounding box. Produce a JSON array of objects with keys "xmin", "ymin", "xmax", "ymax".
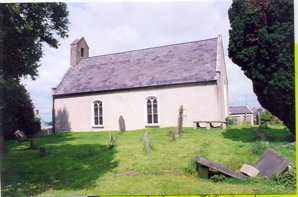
[{"xmin": 54, "ymin": 85, "xmax": 225, "ymax": 131}]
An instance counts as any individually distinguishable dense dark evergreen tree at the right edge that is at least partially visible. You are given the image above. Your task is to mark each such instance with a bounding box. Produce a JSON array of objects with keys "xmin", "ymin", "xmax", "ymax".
[{"xmin": 228, "ymin": 0, "xmax": 295, "ymax": 134}]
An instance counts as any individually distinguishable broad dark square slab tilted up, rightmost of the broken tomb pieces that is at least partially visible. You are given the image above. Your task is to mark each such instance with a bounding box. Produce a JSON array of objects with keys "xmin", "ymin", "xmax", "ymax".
[{"xmin": 254, "ymin": 149, "xmax": 290, "ymax": 178}]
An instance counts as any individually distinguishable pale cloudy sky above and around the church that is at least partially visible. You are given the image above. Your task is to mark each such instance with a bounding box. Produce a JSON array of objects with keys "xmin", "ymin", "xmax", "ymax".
[{"xmin": 22, "ymin": 0, "xmax": 260, "ymax": 121}]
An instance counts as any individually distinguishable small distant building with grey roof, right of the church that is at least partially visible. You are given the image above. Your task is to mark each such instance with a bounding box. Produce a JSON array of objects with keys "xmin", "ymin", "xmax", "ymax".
[{"xmin": 230, "ymin": 106, "xmax": 254, "ymax": 125}]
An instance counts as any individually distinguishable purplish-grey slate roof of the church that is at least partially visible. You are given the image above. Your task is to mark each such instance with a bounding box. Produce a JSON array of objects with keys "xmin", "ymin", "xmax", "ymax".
[{"xmin": 54, "ymin": 38, "xmax": 218, "ymax": 95}]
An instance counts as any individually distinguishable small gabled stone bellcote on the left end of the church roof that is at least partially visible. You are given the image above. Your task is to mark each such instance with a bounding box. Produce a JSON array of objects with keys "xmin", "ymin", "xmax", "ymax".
[{"xmin": 70, "ymin": 37, "xmax": 89, "ymax": 66}]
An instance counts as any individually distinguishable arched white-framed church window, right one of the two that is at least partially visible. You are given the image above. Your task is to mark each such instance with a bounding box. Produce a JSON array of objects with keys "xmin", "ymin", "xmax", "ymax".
[{"xmin": 146, "ymin": 97, "xmax": 159, "ymax": 125}]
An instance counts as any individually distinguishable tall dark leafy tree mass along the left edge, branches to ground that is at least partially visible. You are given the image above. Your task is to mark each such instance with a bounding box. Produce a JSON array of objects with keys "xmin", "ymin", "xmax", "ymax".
[{"xmin": 0, "ymin": 3, "xmax": 69, "ymax": 138}]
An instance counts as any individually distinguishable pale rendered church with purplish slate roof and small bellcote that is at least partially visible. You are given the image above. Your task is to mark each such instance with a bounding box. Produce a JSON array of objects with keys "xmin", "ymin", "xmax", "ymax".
[{"xmin": 53, "ymin": 36, "xmax": 229, "ymax": 132}]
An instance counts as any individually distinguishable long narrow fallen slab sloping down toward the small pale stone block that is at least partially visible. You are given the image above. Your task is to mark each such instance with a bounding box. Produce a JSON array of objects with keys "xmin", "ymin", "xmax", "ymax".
[{"xmin": 195, "ymin": 155, "xmax": 248, "ymax": 179}]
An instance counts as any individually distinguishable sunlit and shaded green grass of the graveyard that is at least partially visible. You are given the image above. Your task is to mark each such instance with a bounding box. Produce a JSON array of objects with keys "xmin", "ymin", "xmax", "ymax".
[{"xmin": 1, "ymin": 127, "xmax": 296, "ymax": 196}]
